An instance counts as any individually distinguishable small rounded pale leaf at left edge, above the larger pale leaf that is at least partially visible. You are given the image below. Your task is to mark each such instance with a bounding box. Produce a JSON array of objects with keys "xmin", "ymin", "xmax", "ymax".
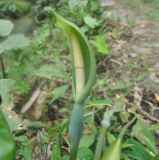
[{"xmin": 0, "ymin": 19, "xmax": 14, "ymax": 37}]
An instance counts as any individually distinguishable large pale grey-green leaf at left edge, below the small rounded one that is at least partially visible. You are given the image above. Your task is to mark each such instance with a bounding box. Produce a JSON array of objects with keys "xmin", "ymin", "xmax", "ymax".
[{"xmin": 0, "ymin": 34, "xmax": 29, "ymax": 54}]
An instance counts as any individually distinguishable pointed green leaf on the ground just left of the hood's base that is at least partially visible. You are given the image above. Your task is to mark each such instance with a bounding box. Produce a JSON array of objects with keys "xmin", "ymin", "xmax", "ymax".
[{"xmin": 50, "ymin": 85, "xmax": 68, "ymax": 104}]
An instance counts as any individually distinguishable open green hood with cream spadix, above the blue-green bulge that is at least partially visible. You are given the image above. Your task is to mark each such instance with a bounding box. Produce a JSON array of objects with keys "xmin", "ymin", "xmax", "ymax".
[{"xmin": 46, "ymin": 8, "xmax": 96, "ymax": 104}]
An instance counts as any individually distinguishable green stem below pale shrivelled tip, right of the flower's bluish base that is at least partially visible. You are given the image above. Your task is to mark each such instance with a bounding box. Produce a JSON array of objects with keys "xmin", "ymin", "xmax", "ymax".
[{"xmin": 94, "ymin": 126, "xmax": 107, "ymax": 160}]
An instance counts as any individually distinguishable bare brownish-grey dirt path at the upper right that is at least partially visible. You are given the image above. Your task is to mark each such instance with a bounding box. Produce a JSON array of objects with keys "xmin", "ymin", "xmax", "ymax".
[{"xmin": 101, "ymin": 0, "xmax": 159, "ymax": 91}]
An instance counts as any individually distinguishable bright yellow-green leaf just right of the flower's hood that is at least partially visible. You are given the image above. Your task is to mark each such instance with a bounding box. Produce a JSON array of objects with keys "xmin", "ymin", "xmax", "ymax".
[{"xmin": 91, "ymin": 36, "xmax": 110, "ymax": 55}]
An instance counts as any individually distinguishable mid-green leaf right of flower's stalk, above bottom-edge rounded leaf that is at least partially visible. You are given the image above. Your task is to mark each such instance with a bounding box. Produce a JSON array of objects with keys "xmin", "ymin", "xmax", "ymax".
[{"xmin": 79, "ymin": 134, "xmax": 95, "ymax": 147}]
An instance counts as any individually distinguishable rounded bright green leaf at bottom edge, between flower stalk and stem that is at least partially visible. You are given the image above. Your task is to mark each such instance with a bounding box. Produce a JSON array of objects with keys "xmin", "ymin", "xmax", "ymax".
[{"xmin": 77, "ymin": 147, "xmax": 93, "ymax": 160}]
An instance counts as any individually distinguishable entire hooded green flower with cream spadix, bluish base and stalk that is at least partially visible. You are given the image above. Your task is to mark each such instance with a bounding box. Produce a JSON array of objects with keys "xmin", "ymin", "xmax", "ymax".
[{"xmin": 45, "ymin": 8, "xmax": 96, "ymax": 160}]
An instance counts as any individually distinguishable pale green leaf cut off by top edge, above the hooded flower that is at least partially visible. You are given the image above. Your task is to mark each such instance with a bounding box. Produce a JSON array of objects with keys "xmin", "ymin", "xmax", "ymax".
[{"xmin": 68, "ymin": 0, "xmax": 88, "ymax": 8}]
